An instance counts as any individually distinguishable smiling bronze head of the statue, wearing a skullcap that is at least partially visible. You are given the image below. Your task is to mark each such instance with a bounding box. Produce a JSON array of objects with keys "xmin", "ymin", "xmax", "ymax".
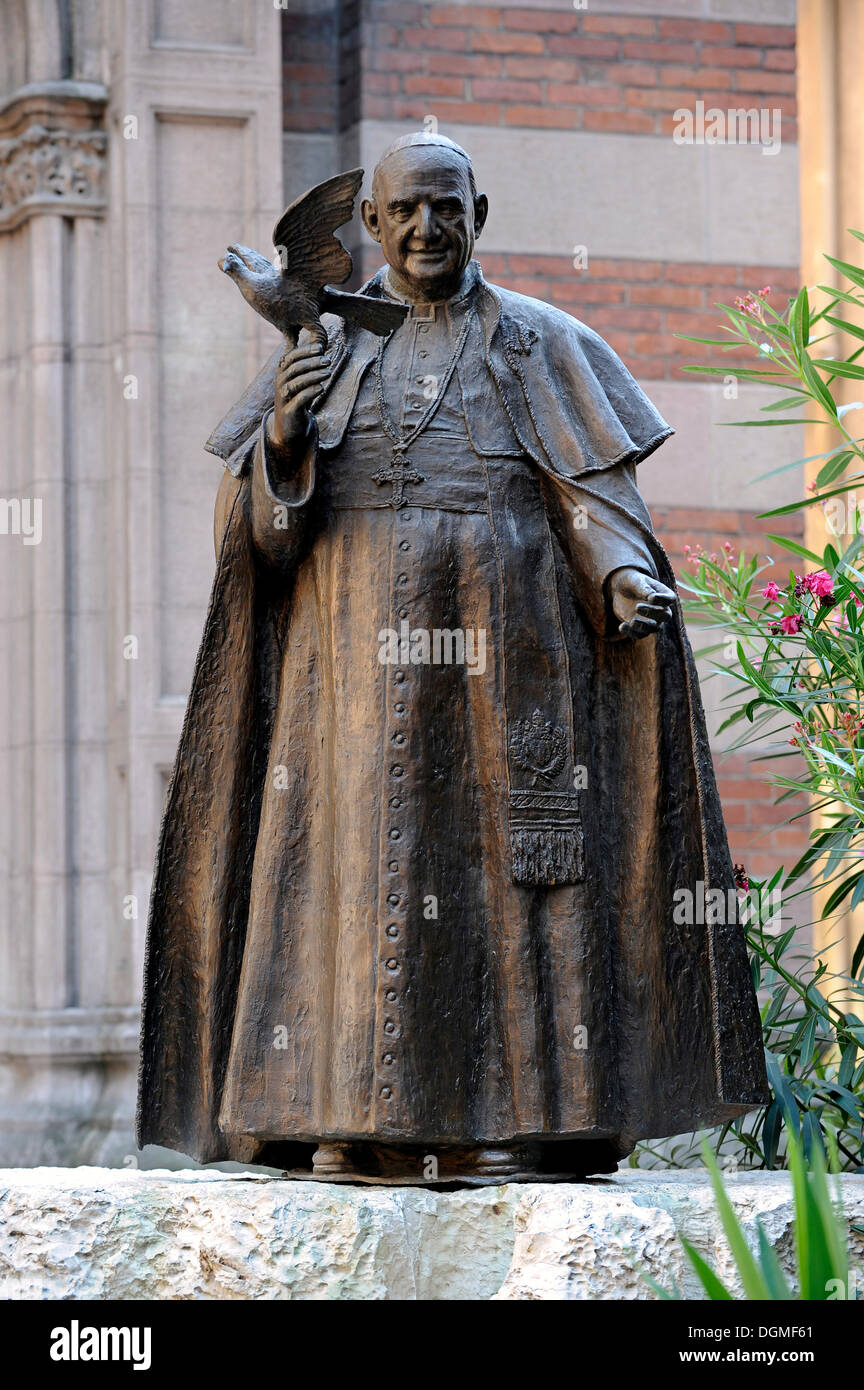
[{"xmin": 361, "ymin": 132, "xmax": 489, "ymax": 300}]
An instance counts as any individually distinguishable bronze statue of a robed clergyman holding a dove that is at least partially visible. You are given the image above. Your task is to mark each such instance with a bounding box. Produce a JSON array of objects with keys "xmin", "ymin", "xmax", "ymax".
[{"xmin": 139, "ymin": 133, "xmax": 768, "ymax": 1182}]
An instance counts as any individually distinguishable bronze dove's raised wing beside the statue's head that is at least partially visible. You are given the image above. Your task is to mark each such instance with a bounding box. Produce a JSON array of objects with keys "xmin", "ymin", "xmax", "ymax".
[{"xmin": 274, "ymin": 170, "xmax": 363, "ymax": 293}]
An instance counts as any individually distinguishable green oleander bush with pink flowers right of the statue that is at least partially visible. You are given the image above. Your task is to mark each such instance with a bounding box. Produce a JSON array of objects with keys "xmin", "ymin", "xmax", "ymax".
[{"xmin": 635, "ymin": 232, "xmax": 864, "ymax": 1172}]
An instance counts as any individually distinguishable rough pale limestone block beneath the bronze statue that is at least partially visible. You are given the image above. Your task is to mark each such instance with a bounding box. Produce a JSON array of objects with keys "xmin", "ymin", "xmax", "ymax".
[{"xmin": 0, "ymin": 1168, "xmax": 864, "ymax": 1300}]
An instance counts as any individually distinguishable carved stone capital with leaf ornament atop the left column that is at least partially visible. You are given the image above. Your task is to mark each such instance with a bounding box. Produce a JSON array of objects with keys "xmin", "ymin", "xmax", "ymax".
[{"xmin": 0, "ymin": 83, "xmax": 107, "ymax": 232}]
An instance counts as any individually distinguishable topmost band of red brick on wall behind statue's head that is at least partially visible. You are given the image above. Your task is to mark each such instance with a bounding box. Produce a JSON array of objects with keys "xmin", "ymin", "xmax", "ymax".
[{"xmin": 361, "ymin": 0, "xmax": 796, "ymax": 140}]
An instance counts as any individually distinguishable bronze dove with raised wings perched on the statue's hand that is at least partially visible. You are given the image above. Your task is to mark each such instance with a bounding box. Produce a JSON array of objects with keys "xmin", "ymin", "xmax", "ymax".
[{"xmin": 219, "ymin": 170, "xmax": 408, "ymax": 348}]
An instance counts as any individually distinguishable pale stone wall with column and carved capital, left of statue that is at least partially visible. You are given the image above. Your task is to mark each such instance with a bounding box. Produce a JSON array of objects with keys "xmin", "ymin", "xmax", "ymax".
[{"xmin": 0, "ymin": 0, "xmax": 282, "ymax": 1163}]
